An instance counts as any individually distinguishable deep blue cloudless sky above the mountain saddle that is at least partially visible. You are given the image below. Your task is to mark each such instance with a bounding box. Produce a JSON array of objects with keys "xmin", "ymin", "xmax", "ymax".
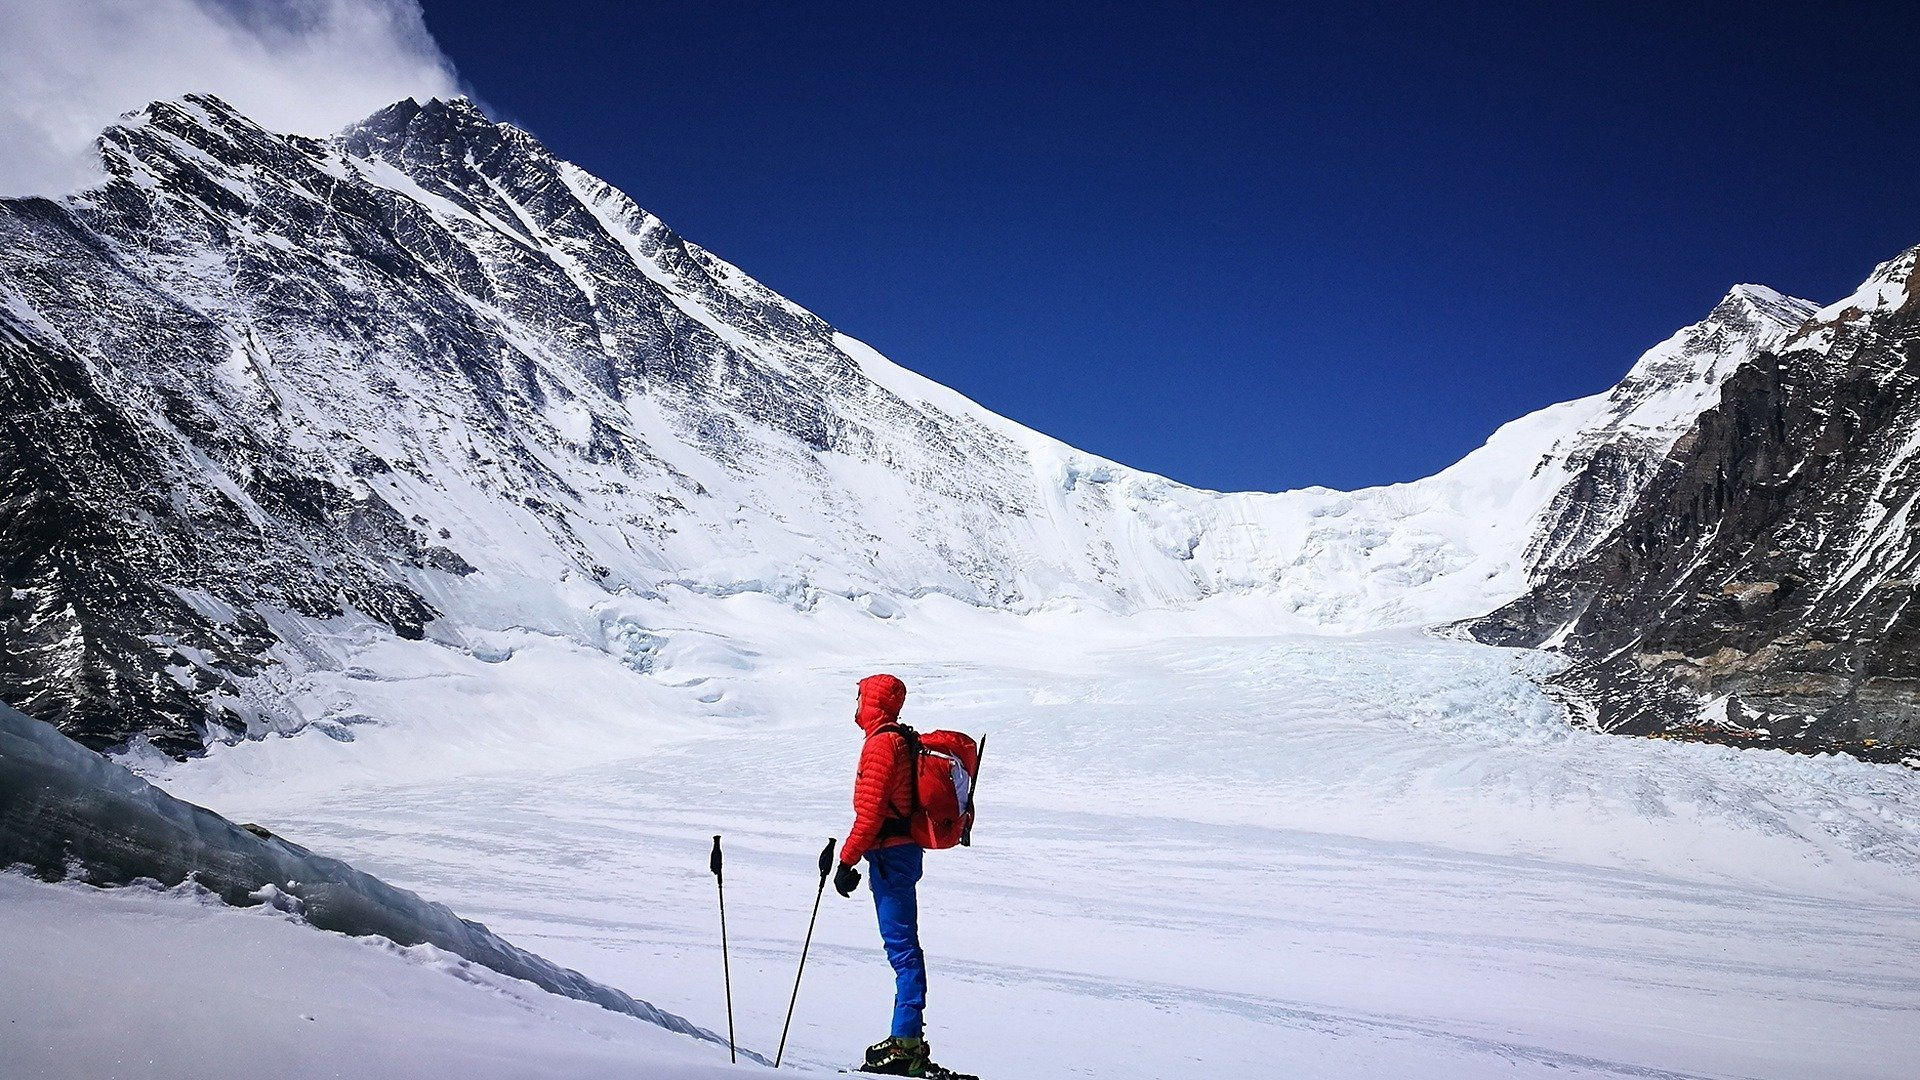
[{"xmin": 426, "ymin": 0, "xmax": 1920, "ymax": 488}]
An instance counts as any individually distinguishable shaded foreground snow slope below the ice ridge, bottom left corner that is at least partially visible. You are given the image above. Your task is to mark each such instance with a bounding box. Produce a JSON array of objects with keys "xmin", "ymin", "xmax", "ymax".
[{"xmin": 0, "ymin": 872, "xmax": 764, "ymax": 1080}]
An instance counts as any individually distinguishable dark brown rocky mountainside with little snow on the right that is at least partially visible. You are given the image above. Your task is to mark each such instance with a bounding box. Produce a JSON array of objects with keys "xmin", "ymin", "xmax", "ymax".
[{"xmin": 1473, "ymin": 252, "xmax": 1920, "ymax": 761}]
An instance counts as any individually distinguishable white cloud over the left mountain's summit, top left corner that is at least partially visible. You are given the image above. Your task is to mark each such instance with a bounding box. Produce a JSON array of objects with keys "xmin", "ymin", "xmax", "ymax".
[{"xmin": 0, "ymin": 0, "xmax": 461, "ymax": 194}]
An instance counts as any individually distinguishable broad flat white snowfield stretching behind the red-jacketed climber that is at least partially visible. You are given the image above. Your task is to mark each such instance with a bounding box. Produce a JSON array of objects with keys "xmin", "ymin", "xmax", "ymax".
[{"xmin": 165, "ymin": 598, "xmax": 1920, "ymax": 1080}]
